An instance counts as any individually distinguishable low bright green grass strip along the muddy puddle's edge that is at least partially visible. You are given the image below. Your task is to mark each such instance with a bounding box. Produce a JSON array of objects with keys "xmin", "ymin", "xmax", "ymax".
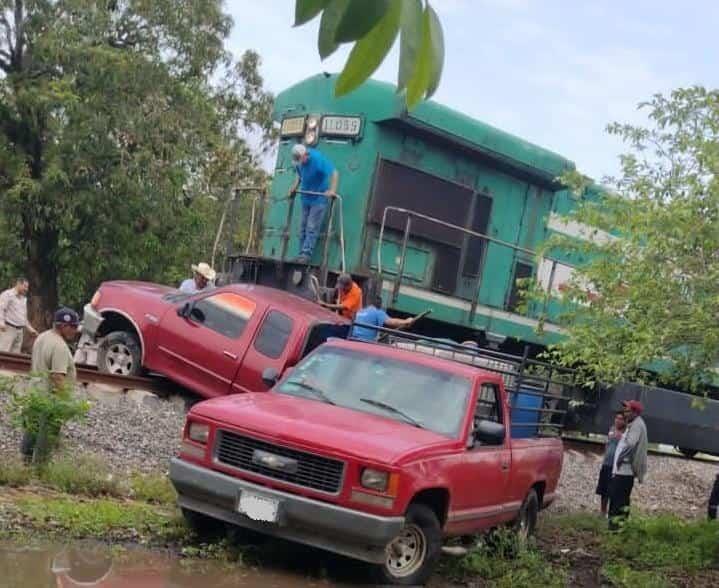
[{"xmin": 16, "ymin": 497, "xmax": 187, "ymax": 541}]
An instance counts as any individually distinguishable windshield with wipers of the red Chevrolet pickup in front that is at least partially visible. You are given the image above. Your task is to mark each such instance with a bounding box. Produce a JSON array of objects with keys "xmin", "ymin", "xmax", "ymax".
[{"xmin": 275, "ymin": 347, "xmax": 471, "ymax": 438}]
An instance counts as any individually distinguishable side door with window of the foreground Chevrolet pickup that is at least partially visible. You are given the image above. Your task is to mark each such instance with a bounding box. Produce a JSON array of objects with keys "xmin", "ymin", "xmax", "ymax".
[{"xmin": 448, "ymin": 384, "xmax": 512, "ymax": 533}]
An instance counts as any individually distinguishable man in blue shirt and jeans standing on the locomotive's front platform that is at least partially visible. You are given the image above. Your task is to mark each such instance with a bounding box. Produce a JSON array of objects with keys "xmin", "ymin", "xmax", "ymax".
[{"xmin": 289, "ymin": 143, "xmax": 339, "ymax": 263}]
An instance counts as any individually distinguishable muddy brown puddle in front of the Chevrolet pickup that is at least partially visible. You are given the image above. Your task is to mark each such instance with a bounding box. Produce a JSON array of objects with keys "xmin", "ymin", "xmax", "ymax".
[{"xmin": 0, "ymin": 541, "xmax": 369, "ymax": 588}]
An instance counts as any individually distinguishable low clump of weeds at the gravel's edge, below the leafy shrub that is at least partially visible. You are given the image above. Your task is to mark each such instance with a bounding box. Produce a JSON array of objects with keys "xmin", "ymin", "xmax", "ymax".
[{"xmin": 40, "ymin": 455, "xmax": 123, "ymax": 496}]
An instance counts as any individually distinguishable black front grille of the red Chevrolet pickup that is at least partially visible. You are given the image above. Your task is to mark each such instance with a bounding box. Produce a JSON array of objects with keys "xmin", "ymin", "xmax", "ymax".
[{"xmin": 215, "ymin": 431, "xmax": 344, "ymax": 494}]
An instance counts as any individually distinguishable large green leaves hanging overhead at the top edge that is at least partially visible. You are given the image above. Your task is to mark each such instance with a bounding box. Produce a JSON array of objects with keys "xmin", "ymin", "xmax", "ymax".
[{"xmin": 295, "ymin": 0, "xmax": 444, "ymax": 108}]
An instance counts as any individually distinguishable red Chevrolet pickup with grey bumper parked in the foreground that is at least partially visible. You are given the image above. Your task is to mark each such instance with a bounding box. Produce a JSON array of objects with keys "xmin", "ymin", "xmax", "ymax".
[{"xmin": 170, "ymin": 339, "xmax": 562, "ymax": 585}]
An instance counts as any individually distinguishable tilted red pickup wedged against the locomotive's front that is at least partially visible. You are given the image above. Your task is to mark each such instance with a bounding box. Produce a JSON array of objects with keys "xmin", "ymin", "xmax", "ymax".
[{"xmin": 76, "ymin": 282, "xmax": 349, "ymax": 398}]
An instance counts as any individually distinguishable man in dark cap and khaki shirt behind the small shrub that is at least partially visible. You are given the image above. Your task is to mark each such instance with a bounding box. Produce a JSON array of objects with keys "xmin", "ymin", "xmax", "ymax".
[{"xmin": 20, "ymin": 308, "xmax": 80, "ymax": 460}]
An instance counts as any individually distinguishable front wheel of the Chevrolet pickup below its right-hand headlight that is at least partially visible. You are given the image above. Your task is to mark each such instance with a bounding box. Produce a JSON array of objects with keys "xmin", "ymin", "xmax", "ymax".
[{"xmin": 375, "ymin": 504, "xmax": 442, "ymax": 586}]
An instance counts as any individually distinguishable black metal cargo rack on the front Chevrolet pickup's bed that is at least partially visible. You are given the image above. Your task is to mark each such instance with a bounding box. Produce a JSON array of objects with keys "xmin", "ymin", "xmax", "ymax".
[{"xmin": 349, "ymin": 322, "xmax": 578, "ymax": 437}]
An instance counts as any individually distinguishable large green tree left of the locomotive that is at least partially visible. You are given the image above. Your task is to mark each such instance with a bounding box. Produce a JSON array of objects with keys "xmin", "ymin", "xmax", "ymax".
[{"xmin": 0, "ymin": 0, "xmax": 272, "ymax": 324}]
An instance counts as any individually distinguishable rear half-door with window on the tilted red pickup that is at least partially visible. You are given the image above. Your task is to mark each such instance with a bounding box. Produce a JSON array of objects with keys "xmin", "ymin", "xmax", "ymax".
[{"xmin": 235, "ymin": 308, "xmax": 302, "ymax": 391}]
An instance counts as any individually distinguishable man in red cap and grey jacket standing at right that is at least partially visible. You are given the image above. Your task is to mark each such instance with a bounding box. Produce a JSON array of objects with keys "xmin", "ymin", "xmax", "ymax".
[{"xmin": 609, "ymin": 400, "xmax": 649, "ymax": 530}]
